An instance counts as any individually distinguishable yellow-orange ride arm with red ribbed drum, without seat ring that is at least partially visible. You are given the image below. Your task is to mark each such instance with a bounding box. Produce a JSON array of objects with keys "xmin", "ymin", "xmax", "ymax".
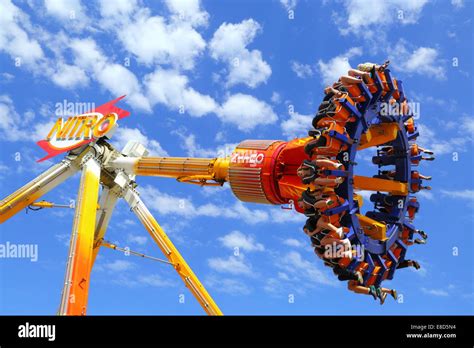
[{"xmin": 109, "ymin": 138, "xmax": 312, "ymax": 209}]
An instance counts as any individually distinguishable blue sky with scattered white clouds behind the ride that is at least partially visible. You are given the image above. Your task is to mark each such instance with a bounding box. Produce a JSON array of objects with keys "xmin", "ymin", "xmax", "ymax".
[{"xmin": 0, "ymin": 0, "xmax": 474, "ymax": 315}]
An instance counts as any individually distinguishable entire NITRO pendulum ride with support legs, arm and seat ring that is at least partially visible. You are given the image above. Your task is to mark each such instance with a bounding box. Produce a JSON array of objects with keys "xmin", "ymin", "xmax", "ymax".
[{"xmin": 0, "ymin": 65, "xmax": 429, "ymax": 315}]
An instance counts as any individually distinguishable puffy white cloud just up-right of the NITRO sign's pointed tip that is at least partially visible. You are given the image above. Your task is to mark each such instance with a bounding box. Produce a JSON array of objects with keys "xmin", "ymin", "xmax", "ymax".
[{"xmin": 144, "ymin": 69, "xmax": 217, "ymax": 116}]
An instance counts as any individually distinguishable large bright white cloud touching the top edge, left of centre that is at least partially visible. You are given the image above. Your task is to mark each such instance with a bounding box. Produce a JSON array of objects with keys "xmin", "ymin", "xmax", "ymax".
[{"xmin": 100, "ymin": 0, "xmax": 209, "ymax": 70}]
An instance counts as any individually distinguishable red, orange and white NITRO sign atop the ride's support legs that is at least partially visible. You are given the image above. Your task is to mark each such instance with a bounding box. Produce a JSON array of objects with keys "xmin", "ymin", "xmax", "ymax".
[{"xmin": 37, "ymin": 96, "xmax": 130, "ymax": 162}]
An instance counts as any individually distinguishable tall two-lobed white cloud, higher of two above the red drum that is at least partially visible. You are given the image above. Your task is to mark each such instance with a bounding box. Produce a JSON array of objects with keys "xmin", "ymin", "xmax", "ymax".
[{"xmin": 209, "ymin": 19, "xmax": 272, "ymax": 88}]
